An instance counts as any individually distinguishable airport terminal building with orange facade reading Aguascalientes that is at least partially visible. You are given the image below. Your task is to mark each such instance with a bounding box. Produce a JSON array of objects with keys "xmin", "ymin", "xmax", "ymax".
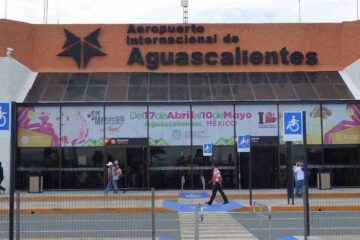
[{"xmin": 0, "ymin": 20, "xmax": 360, "ymax": 189}]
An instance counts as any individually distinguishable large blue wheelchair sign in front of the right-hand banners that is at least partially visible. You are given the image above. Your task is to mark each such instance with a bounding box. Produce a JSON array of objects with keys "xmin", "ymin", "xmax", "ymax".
[{"xmin": 283, "ymin": 112, "xmax": 303, "ymax": 141}]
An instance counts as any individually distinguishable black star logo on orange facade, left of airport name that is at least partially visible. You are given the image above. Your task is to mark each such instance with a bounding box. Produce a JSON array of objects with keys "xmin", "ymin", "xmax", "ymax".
[{"xmin": 57, "ymin": 28, "xmax": 106, "ymax": 68}]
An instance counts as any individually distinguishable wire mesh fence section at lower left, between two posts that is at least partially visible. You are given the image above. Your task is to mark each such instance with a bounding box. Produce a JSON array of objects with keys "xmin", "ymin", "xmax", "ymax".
[{"xmin": 7, "ymin": 189, "xmax": 155, "ymax": 240}]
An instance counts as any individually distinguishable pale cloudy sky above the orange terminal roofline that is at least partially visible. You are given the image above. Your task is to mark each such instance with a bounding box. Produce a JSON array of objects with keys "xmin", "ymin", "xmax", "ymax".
[{"xmin": 0, "ymin": 0, "xmax": 358, "ymax": 23}]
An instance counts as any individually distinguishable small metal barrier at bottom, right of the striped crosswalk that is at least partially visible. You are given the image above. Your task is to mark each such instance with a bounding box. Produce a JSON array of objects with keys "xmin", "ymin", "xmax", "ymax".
[{"xmin": 253, "ymin": 202, "xmax": 272, "ymax": 240}]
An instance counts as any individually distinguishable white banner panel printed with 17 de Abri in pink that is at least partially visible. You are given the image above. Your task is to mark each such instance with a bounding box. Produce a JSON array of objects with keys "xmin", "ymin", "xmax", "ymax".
[{"xmin": 145, "ymin": 106, "xmax": 191, "ymax": 146}]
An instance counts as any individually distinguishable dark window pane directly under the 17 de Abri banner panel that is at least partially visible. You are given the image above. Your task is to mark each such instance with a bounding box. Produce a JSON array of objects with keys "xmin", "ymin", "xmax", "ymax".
[{"xmin": 150, "ymin": 146, "xmax": 191, "ymax": 167}]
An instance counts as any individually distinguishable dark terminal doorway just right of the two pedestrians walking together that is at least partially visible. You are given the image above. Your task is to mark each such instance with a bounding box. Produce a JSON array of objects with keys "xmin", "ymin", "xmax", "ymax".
[{"xmin": 106, "ymin": 146, "xmax": 147, "ymax": 188}]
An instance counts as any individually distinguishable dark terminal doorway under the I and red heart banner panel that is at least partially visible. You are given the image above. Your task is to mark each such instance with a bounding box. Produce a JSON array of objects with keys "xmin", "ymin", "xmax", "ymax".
[{"xmin": 239, "ymin": 146, "xmax": 279, "ymax": 189}]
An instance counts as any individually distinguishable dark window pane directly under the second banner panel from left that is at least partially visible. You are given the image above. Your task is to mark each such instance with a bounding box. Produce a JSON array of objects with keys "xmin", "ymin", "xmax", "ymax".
[{"xmin": 61, "ymin": 147, "xmax": 105, "ymax": 168}]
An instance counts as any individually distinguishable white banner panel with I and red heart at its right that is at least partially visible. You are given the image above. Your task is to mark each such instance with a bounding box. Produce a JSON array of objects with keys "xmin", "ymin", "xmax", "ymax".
[{"xmin": 235, "ymin": 105, "xmax": 278, "ymax": 137}]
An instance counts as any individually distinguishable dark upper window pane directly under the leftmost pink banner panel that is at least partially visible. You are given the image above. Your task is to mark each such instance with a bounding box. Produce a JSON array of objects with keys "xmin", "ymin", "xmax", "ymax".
[{"xmin": 18, "ymin": 148, "xmax": 60, "ymax": 168}]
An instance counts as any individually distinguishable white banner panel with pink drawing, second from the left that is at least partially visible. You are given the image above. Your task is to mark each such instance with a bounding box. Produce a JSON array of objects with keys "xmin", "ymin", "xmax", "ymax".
[{"xmin": 61, "ymin": 106, "xmax": 104, "ymax": 147}]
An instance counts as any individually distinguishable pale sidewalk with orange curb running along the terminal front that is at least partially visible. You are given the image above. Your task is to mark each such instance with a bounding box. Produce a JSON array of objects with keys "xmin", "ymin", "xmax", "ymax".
[{"xmin": 0, "ymin": 188, "xmax": 360, "ymax": 214}]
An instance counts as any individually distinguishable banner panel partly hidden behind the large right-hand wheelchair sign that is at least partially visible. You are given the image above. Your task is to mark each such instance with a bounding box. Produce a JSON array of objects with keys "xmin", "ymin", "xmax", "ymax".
[{"xmin": 279, "ymin": 104, "xmax": 321, "ymax": 144}]
